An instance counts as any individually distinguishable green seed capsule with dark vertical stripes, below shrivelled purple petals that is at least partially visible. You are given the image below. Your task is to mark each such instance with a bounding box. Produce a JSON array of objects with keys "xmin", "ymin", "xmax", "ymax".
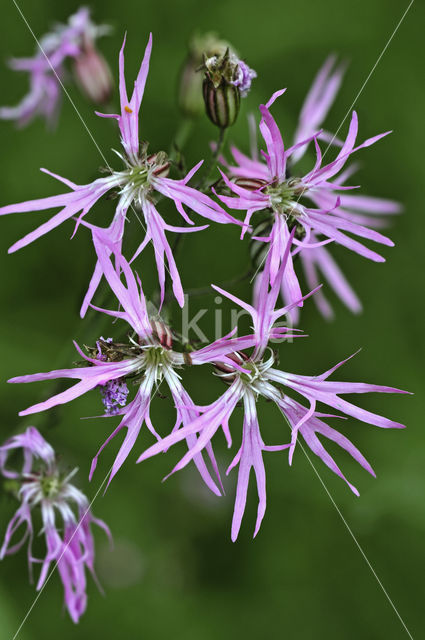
[{"xmin": 203, "ymin": 76, "xmax": 241, "ymax": 129}]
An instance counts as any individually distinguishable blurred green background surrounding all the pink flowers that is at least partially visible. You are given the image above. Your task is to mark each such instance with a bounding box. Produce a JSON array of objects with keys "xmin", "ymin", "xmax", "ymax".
[{"xmin": 0, "ymin": 0, "xmax": 425, "ymax": 640}]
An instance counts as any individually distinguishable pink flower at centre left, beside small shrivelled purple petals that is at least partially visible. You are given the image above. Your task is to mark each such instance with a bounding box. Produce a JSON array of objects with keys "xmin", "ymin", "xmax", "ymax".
[{"xmin": 9, "ymin": 243, "xmax": 255, "ymax": 495}]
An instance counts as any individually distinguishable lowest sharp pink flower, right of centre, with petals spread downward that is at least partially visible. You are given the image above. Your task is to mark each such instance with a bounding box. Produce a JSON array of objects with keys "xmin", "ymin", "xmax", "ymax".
[{"xmin": 138, "ymin": 235, "xmax": 404, "ymax": 540}]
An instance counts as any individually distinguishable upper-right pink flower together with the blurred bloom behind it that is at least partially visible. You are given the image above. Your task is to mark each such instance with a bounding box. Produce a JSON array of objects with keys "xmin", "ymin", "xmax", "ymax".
[{"xmin": 222, "ymin": 56, "xmax": 401, "ymax": 323}]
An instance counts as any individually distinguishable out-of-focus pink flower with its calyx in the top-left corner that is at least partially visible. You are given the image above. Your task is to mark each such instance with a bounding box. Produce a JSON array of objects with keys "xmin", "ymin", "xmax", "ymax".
[{"xmin": 0, "ymin": 7, "xmax": 110, "ymax": 126}]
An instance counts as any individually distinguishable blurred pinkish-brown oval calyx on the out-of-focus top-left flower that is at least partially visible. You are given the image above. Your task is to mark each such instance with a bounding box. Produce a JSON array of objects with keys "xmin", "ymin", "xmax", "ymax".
[{"xmin": 74, "ymin": 43, "xmax": 113, "ymax": 104}]
